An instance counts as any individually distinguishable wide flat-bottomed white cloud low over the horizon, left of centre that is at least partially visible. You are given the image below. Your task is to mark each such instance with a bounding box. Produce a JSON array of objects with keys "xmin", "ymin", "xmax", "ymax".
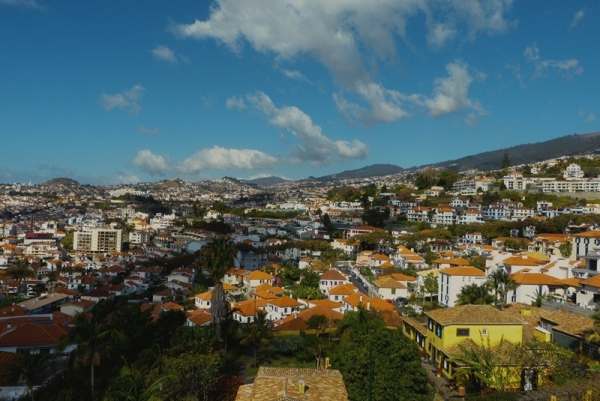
[{"xmin": 177, "ymin": 146, "xmax": 277, "ymax": 174}]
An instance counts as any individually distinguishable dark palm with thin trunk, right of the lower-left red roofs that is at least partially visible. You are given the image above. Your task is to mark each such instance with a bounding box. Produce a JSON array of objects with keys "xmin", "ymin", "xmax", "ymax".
[{"xmin": 58, "ymin": 313, "xmax": 124, "ymax": 400}]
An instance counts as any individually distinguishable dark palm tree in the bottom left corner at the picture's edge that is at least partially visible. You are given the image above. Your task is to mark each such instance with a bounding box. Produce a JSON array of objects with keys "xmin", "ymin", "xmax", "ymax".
[{"xmin": 2, "ymin": 349, "xmax": 51, "ymax": 401}]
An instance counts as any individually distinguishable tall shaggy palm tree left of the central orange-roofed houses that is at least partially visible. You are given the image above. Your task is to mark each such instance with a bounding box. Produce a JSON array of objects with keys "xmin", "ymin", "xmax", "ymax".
[{"xmin": 200, "ymin": 237, "xmax": 237, "ymax": 339}]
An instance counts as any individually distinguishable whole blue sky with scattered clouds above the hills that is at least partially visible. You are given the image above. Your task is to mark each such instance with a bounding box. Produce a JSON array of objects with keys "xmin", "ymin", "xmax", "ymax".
[{"xmin": 0, "ymin": 0, "xmax": 600, "ymax": 184}]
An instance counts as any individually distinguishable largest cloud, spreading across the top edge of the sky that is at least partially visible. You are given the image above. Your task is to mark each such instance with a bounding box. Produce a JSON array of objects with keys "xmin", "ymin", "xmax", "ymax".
[{"xmin": 171, "ymin": 0, "xmax": 513, "ymax": 125}]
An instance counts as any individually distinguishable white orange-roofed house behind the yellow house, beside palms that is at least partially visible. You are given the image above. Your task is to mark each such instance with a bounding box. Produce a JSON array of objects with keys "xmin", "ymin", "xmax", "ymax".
[{"xmin": 438, "ymin": 266, "xmax": 486, "ymax": 308}]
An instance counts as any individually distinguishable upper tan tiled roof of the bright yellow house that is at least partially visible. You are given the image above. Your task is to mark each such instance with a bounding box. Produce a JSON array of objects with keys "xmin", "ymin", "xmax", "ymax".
[{"xmin": 425, "ymin": 305, "xmax": 523, "ymax": 326}]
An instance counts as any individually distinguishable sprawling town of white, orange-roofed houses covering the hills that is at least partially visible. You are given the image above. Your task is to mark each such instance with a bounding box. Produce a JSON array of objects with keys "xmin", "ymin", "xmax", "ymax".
[{"xmin": 0, "ymin": 155, "xmax": 600, "ymax": 400}]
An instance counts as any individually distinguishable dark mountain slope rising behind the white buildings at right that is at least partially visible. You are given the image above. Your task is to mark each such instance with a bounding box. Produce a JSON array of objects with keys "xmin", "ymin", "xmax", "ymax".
[{"xmin": 428, "ymin": 132, "xmax": 600, "ymax": 171}]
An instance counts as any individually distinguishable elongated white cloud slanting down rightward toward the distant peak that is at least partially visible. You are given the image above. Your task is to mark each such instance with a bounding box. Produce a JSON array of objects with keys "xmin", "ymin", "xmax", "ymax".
[{"xmin": 246, "ymin": 92, "xmax": 370, "ymax": 165}]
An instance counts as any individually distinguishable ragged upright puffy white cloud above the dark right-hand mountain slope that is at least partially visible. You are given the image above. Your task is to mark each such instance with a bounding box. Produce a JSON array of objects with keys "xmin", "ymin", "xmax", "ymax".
[{"xmin": 425, "ymin": 62, "xmax": 484, "ymax": 119}]
